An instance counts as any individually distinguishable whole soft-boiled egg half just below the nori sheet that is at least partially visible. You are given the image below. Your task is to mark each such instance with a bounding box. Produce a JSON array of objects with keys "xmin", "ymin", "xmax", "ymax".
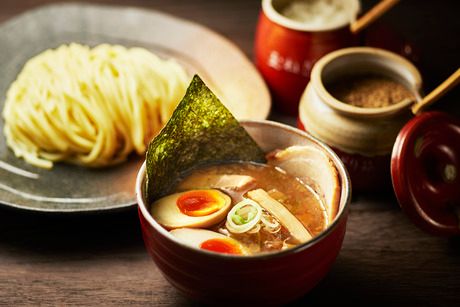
[{"xmin": 151, "ymin": 189, "xmax": 231, "ymax": 229}]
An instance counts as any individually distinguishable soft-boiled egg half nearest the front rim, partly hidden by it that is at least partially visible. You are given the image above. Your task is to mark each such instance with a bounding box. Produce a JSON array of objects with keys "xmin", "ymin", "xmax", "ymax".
[{"xmin": 169, "ymin": 228, "xmax": 248, "ymax": 255}]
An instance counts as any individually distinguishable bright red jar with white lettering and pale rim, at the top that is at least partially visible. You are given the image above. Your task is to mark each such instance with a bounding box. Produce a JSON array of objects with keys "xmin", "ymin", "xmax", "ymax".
[{"xmin": 254, "ymin": 0, "xmax": 359, "ymax": 115}]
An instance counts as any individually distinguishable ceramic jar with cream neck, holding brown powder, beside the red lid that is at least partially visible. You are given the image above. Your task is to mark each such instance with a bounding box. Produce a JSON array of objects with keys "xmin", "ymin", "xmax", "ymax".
[{"xmin": 298, "ymin": 47, "xmax": 422, "ymax": 190}]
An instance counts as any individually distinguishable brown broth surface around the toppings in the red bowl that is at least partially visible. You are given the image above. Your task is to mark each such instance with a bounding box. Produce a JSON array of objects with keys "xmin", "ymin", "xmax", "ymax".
[{"xmin": 175, "ymin": 162, "xmax": 327, "ymax": 252}]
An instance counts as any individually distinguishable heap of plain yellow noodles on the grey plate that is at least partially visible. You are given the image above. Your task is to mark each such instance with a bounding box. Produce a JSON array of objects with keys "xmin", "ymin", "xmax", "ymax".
[{"xmin": 3, "ymin": 44, "xmax": 189, "ymax": 168}]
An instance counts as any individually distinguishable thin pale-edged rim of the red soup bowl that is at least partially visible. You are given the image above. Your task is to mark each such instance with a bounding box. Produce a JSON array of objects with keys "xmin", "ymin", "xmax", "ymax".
[{"xmin": 136, "ymin": 120, "xmax": 351, "ymax": 261}]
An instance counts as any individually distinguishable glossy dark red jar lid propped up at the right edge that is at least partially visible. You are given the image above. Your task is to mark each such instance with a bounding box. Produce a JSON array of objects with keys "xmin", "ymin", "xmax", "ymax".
[{"xmin": 391, "ymin": 112, "xmax": 460, "ymax": 235}]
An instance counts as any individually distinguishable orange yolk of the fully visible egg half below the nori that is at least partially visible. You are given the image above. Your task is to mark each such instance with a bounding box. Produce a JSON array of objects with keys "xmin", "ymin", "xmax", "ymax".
[{"xmin": 176, "ymin": 190, "xmax": 225, "ymax": 216}]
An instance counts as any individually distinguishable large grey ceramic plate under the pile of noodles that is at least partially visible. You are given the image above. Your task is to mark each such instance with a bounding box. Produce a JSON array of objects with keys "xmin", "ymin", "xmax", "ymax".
[{"xmin": 0, "ymin": 4, "xmax": 270, "ymax": 212}]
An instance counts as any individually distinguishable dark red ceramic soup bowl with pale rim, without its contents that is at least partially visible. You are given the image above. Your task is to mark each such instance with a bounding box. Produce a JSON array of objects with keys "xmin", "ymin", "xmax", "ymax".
[{"xmin": 136, "ymin": 121, "xmax": 351, "ymax": 304}]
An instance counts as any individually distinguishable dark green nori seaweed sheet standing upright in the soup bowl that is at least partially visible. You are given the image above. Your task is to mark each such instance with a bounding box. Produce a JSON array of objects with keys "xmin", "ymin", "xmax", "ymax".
[{"xmin": 145, "ymin": 75, "xmax": 266, "ymax": 203}]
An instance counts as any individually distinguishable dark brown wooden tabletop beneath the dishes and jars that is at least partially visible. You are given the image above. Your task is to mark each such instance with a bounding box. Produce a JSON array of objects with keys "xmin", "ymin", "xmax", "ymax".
[{"xmin": 0, "ymin": 0, "xmax": 460, "ymax": 306}]
